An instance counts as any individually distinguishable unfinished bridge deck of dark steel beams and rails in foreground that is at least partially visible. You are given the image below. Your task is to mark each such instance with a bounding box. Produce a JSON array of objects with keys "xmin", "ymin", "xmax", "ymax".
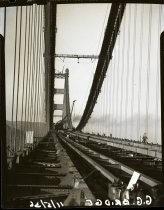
[{"xmin": 7, "ymin": 132, "xmax": 162, "ymax": 208}]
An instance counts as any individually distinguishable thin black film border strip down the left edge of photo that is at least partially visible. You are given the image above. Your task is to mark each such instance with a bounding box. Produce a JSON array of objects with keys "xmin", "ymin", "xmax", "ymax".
[{"xmin": 0, "ymin": 34, "xmax": 7, "ymax": 208}]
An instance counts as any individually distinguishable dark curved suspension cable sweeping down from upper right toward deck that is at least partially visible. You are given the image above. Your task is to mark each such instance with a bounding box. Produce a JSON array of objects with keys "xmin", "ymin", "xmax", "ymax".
[{"xmin": 76, "ymin": 4, "xmax": 126, "ymax": 130}]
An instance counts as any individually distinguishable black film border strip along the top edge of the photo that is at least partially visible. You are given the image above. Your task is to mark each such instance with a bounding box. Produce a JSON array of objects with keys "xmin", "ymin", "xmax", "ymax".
[{"xmin": 0, "ymin": 0, "xmax": 163, "ymax": 7}]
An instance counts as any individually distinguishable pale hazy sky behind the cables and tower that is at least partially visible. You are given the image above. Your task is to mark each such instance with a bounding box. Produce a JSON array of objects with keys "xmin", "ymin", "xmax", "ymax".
[{"xmin": 0, "ymin": 4, "xmax": 164, "ymax": 143}]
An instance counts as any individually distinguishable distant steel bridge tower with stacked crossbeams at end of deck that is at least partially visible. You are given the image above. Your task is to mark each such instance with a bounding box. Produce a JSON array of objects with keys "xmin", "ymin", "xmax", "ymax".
[{"xmin": 54, "ymin": 69, "xmax": 72, "ymax": 129}]
